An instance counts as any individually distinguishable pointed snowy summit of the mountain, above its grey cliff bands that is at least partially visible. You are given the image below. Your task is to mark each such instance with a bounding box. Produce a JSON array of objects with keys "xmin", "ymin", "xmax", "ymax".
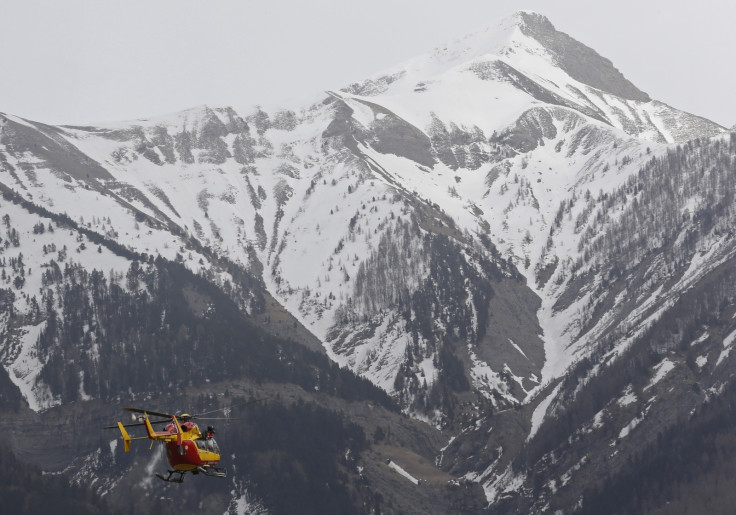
[{"xmin": 345, "ymin": 11, "xmax": 724, "ymax": 142}]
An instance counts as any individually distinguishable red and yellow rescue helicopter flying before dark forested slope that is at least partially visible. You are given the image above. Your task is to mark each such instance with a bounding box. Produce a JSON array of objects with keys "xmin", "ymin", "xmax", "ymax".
[{"xmin": 104, "ymin": 399, "xmax": 265, "ymax": 483}]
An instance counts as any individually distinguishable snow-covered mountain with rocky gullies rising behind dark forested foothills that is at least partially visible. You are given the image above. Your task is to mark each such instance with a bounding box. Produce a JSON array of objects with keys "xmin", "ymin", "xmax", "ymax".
[{"xmin": 0, "ymin": 12, "xmax": 735, "ymax": 509}]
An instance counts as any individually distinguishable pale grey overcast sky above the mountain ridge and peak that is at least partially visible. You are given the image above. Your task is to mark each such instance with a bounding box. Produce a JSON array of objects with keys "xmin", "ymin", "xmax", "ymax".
[{"xmin": 0, "ymin": 0, "xmax": 736, "ymax": 127}]
